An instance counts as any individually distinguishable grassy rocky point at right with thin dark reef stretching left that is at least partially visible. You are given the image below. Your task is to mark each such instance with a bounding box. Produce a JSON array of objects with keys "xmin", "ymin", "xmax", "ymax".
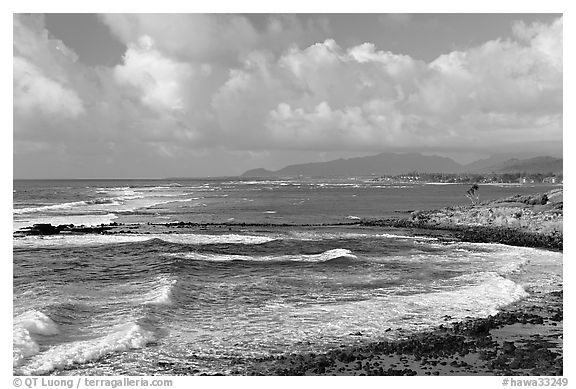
[{"xmin": 13, "ymin": 188, "xmax": 563, "ymax": 251}]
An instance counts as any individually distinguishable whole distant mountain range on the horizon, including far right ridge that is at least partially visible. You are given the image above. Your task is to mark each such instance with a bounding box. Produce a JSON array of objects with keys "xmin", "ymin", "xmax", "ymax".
[{"xmin": 242, "ymin": 153, "xmax": 562, "ymax": 177}]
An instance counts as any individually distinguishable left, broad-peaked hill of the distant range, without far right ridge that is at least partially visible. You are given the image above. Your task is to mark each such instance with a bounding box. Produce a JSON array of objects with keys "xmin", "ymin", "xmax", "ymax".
[{"xmin": 242, "ymin": 153, "xmax": 462, "ymax": 177}]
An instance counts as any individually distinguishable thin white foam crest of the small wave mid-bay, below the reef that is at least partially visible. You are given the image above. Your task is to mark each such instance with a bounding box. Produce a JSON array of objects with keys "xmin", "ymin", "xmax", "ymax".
[{"xmin": 165, "ymin": 249, "xmax": 357, "ymax": 262}]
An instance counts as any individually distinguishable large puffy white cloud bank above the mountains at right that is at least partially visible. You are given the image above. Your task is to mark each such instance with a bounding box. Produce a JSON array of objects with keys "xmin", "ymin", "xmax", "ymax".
[{"xmin": 214, "ymin": 18, "xmax": 562, "ymax": 149}]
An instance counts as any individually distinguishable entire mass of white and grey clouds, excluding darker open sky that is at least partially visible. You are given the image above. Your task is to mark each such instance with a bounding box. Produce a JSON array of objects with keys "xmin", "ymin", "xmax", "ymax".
[{"xmin": 13, "ymin": 14, "xmax": 563, "ymax": 174}]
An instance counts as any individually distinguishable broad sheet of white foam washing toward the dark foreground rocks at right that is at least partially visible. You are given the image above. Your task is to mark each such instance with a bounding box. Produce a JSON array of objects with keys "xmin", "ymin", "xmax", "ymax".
[{"xmin": 272, "ymin": 273, "xmax": 527, "ymax": 342}]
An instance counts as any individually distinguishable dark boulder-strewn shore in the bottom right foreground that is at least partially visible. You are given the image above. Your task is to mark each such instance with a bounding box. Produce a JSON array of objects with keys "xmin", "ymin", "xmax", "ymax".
[{"xmin": 233, "ymin": 291, "xmax": 563, "ymax": 376}]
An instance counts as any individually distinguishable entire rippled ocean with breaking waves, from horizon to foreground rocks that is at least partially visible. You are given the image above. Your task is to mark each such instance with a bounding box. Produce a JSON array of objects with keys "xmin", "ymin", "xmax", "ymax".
[{"xmin": 13, "ymin": 178, "xmax": 562, "ymax": 375}]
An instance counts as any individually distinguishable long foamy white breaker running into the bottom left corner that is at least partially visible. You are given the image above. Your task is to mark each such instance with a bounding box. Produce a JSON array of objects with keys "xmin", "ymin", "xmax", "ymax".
[{"xmin": 15, "ymin": 323, "xmax": 154, "ymax": 375}]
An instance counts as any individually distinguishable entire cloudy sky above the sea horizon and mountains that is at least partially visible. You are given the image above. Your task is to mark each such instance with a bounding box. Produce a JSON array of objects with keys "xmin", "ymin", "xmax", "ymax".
[{"xmin": 13, "ymin": 13, "xmax": 563, "ymax": 178}]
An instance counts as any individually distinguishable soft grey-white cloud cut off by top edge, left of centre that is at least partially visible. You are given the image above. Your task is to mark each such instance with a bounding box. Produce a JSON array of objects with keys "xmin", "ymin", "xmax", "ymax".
[{"xmin": 100, "ymin": 14, "xmax": 329, "ymax": 64}]
